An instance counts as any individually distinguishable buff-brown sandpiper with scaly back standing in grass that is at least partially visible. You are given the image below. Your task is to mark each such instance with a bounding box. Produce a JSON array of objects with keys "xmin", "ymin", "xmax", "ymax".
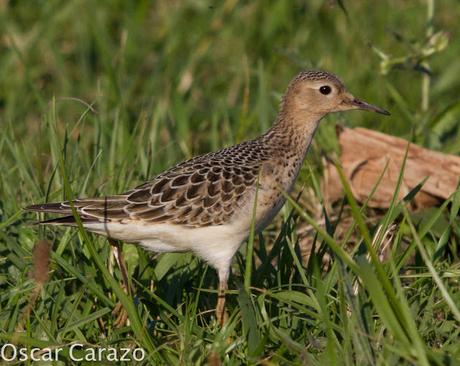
[{"xmin": 25, "ymin": 70, "xmax": 390, "ymax": 325}]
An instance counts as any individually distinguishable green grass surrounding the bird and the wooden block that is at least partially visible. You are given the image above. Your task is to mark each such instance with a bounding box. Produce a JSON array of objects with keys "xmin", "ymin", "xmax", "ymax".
[{"xmin": 0, "ymin": 0, "xmax": 460, "ymax": 365}]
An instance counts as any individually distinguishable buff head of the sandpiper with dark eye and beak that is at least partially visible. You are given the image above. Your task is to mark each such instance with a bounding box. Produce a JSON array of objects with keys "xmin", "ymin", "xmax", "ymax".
[{"xmin": 284, "ymin": 71, "xmax": 390, "ymax": 116}]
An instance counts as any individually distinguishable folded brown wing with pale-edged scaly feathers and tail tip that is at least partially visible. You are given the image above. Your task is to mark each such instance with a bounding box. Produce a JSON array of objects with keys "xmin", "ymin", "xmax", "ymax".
[{"xmin": 26, "ymin": 139, "xmax": 264, "ymax": 227}]
